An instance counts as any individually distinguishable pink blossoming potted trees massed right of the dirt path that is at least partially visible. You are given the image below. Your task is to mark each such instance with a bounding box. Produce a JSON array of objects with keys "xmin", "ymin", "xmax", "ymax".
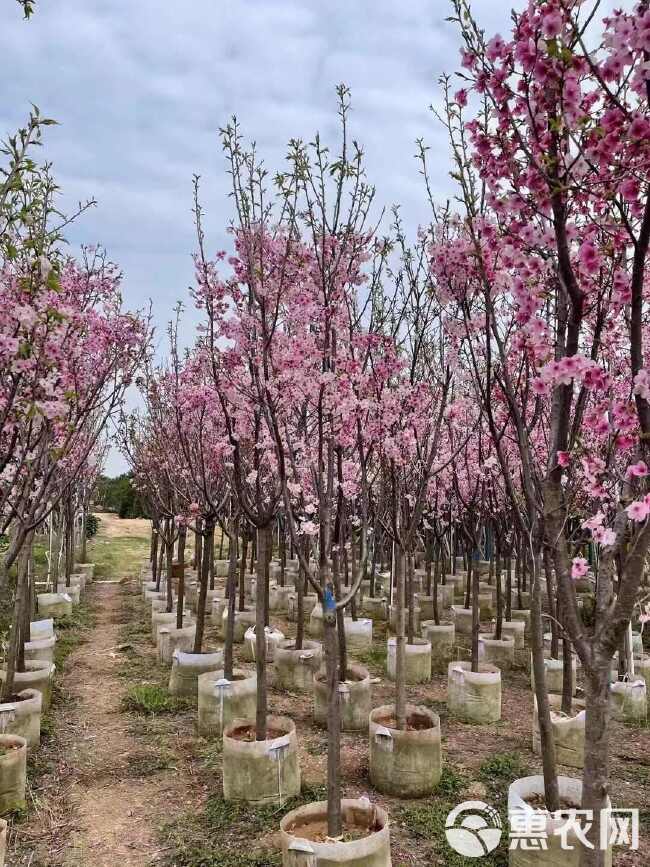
[{"xmin": 122, "ymin": 0, "xmax": 650, "ymax": 864}]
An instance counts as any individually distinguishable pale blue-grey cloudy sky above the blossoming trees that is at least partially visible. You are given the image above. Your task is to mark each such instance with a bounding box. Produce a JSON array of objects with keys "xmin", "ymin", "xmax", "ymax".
[{"xmin": 0, "ymin": 0, "xmax": 509, "ymax": 472}]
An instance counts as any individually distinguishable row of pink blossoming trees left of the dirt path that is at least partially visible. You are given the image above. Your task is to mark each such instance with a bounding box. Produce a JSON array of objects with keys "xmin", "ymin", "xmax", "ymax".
[{"xmin": 0, "ymin": 109, "xmax": 148, "ymax": 701}]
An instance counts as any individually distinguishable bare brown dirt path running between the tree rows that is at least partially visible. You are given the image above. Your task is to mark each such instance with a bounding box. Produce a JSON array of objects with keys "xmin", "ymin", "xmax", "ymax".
[{"xmin": 16, "ymin": 582, "xmax": 199, "ymax": 867}]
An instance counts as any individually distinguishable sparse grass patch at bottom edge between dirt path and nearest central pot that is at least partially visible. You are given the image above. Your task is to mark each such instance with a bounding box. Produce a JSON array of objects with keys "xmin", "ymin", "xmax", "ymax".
[{"xmin": 156, "ymin": 786, "xmax": 326, "ymax": 867}]
